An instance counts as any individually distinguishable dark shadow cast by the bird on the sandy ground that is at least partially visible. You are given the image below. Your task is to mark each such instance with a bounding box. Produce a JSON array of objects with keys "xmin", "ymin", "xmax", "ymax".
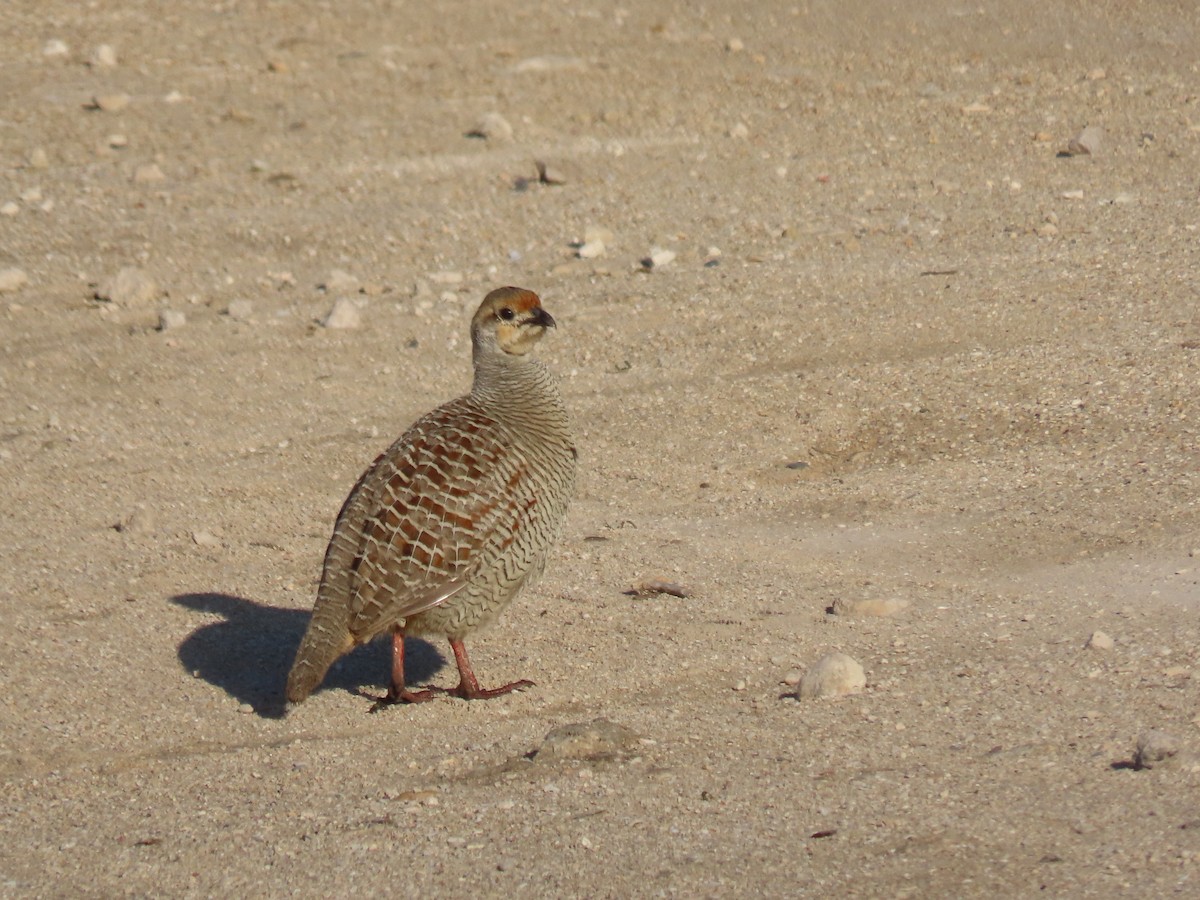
[{"xmin": 170, "ymin": 594, "xmax": 446, "ymax": 719}]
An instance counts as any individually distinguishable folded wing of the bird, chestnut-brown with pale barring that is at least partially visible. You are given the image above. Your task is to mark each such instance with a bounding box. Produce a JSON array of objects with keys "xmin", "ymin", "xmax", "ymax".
[{"xmin": 325, "ymin": 398, "xmax": 532, "ymax": 641}]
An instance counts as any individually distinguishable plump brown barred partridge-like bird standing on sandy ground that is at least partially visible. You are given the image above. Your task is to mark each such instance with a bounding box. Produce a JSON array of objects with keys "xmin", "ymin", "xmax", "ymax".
[{"xmin": 287, "ymin": 287, "xmax": 578, "ymax": 712}]
